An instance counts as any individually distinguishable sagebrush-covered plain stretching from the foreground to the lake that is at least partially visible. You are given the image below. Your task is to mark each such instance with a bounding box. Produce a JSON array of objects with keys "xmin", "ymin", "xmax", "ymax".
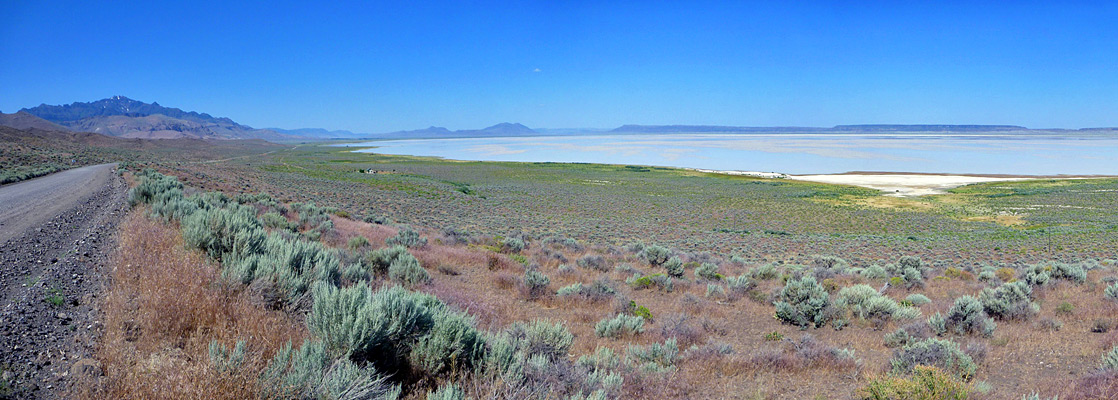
[{"xmin": 74, "ymin": 143, "xmax": 1118, "ymax": 399}]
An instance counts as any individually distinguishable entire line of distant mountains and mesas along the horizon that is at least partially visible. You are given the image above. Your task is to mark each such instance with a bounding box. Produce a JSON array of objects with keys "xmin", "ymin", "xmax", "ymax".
[{"xmin": 0, "ymin": 96, "xmax": 1116, "ymax": 142}]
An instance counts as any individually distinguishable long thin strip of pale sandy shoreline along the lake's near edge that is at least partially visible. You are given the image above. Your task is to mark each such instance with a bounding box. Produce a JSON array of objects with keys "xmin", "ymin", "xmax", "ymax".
[{"xmin": 694, "ymin": 169, "xmax": 1112, "ymax": 197}]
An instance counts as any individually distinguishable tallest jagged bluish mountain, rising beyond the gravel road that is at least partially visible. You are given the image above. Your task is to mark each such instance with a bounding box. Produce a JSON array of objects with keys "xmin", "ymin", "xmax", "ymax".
[{"xmin": 20, "ymin": 96, "xmax": 292, "ymax": 142}]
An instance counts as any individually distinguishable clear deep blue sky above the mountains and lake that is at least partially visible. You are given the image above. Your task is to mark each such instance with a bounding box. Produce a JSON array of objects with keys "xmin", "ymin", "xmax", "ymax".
[{"xmin": 0, "ymin": 0, "xmax": 1118, "ymax": 132}]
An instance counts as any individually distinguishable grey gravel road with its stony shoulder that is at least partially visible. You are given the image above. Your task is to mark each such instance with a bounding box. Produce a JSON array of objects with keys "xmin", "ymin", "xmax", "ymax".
[{"xmin": 0, "ymin": 164, "xmax": 127, "ymax": 399}]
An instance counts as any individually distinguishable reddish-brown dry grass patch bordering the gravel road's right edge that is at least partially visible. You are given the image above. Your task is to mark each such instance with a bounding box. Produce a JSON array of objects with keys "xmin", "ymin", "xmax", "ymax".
[{"xmin": 75, "ymin": 209, "xmax": 306, "ymax": 399}]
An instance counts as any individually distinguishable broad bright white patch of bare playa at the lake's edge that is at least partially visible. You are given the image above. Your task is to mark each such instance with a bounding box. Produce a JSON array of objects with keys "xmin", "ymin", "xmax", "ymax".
[{"xmin": 787, "ymin": 173, "xmax": 1029, "ymax": 197}]
